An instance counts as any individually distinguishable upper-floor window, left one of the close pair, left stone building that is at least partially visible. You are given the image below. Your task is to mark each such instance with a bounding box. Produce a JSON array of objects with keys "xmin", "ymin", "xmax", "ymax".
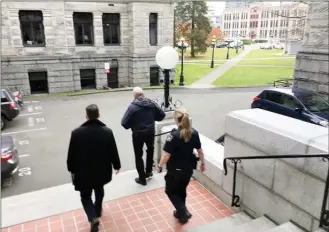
[{"xmin": 73, "ymin": 12, "xmax": 94, "ymax": 45}]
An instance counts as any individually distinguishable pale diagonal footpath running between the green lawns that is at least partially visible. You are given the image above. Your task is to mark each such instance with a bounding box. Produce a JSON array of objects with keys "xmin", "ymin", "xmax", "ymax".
[{"xmin": 188, "ymin": 47, "xmax": 254, "ymax": 89}]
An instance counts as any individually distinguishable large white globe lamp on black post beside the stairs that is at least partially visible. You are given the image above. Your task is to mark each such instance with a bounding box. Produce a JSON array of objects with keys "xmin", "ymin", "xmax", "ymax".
[{"xmin": 155, "ymin": 46, "xmax": 179, "ymax": 111}]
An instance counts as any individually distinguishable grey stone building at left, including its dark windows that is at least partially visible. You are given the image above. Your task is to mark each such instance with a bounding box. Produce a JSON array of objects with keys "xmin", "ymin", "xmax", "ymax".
[{"xmin": 1, "ymin": 0, "xmax": 174, "ymax": 95}]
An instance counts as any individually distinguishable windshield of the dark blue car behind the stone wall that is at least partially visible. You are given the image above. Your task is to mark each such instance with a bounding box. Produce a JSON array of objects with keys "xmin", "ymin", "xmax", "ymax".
[{"xmin": 296, "ymin": 94, "xmax": 329, "ymax": 112}]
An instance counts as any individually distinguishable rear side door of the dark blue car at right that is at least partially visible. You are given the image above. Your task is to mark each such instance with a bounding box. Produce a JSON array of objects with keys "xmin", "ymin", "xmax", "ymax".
[{"xmin": 259, "ymin": 90, "xmax": 282, "ymax": 114}]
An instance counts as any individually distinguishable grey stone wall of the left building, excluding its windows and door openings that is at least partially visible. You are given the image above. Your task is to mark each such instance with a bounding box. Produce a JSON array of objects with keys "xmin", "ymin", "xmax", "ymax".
[{"xmin": 1, "ymin": 0, "xmax": 174, "ymax": 94}]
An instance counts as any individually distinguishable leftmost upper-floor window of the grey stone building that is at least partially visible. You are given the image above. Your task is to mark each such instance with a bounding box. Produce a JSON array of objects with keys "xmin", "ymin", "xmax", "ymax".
[{"xmin": 18, "ymin": 10, "xmax": 46, "ymax": 46}]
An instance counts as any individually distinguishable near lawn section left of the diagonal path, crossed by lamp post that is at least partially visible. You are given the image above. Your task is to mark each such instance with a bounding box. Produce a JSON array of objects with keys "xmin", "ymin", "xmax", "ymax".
[{"xmin": 176, "ymin": 64, "xmax": 218, "ymax": 85}]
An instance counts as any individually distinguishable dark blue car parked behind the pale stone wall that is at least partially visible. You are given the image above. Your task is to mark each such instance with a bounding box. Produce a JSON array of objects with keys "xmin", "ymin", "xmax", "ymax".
[{"xmin": 251, "ymin": 88, "xmax": 329, "ymax": 127}]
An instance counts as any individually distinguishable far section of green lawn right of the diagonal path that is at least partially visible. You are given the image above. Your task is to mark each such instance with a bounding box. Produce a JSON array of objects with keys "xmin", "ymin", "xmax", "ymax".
[{"xmin": 238, "ymin": 49, "xmax": 296, "ymax": 66}]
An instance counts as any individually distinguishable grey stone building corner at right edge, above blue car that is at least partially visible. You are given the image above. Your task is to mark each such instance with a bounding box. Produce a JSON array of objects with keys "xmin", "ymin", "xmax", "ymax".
[{"xmin": 294, "ymin": 2, "xmax": 329, "ymax": 99}]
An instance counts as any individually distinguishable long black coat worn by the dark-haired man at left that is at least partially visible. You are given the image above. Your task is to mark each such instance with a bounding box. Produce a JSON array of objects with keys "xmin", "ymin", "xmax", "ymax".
[{"xmin": 67, "ymin": 120, "xmax": 121, "ymax": 191}]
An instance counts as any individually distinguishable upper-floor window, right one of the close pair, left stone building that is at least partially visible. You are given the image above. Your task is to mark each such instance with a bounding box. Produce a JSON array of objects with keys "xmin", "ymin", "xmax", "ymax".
[{"xmin": 102, "ymin": 13, "xmax": 120, "ymax": 45}]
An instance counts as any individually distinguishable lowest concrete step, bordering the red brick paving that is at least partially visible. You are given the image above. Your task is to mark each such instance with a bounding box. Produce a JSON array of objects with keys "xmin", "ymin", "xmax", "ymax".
[{"xmin": 185, "ymin": 213, "xmax": 252, "ymax": 232}]
